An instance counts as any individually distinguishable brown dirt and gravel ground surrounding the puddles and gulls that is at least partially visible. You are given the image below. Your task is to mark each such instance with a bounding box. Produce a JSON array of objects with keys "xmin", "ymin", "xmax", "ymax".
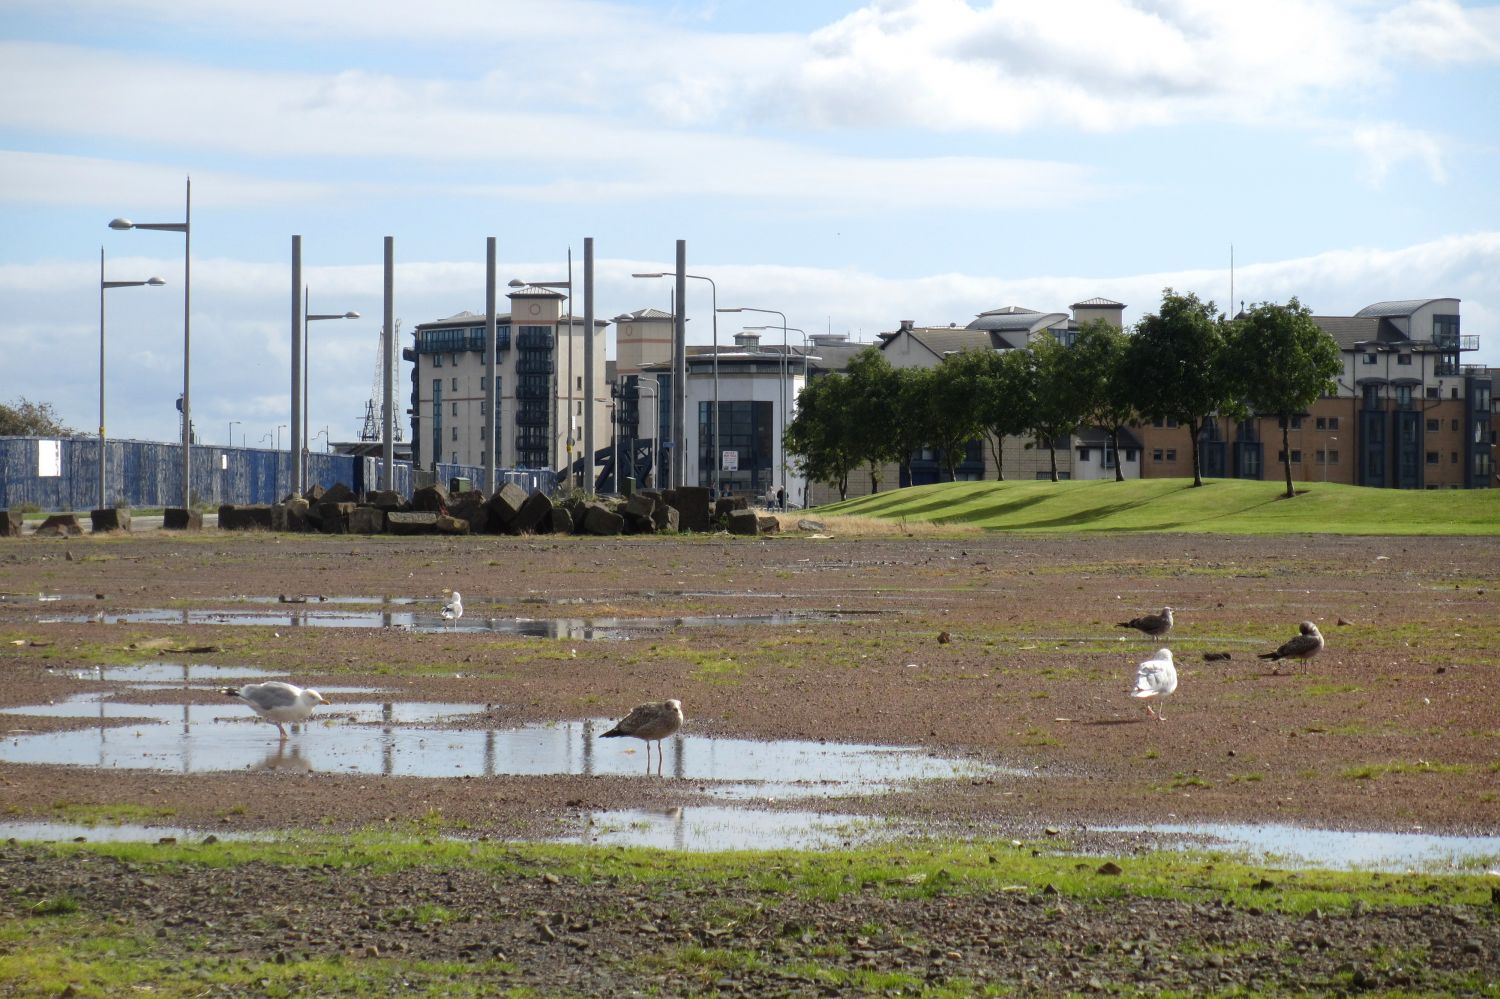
[{"xmin": 0, "ymin": 531, "xmax": 1500, "ymax": 995}]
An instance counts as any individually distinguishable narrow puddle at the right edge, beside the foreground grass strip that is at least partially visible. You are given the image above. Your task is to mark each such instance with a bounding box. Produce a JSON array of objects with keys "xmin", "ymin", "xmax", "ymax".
[{"xmin": 1103, "ymin": 824, "xmax": 1500, "ymax": 872}]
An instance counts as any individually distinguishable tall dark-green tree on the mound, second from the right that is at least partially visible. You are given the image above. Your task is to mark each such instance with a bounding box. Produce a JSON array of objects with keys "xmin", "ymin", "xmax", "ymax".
[{"xmin": 1124, "ymin": 288, "xmax": 1238, "ymax": 486}]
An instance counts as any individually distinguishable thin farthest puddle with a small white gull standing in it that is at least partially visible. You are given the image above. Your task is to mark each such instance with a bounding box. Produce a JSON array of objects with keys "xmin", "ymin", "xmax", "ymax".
[{"xmin": 41, "ymin": 605, "xmax": 848, "ymax": 642}]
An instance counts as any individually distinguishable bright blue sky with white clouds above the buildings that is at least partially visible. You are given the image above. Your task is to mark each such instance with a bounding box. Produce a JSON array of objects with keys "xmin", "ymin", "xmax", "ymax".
[{"xmin": 0, "ymin": 0, "xmax": 1500, "ymax": 447}]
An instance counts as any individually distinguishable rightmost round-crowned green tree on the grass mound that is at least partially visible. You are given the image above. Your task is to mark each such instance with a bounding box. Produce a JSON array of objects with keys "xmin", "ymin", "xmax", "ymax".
[{"xmin": 1227, "ymin": 299, "xmax": 1344, "ymax": 500}]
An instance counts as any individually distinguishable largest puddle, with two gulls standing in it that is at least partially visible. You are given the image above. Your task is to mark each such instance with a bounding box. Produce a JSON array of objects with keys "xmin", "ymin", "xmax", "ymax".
[{"xmin": 0, "ymin": 693, "xmax": 1022, "ymax": 801}]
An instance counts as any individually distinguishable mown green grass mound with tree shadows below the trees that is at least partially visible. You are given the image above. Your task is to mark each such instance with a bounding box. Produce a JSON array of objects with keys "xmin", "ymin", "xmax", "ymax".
[{"xmin": 816, "ymin": 479, "xmax": 1500, "ymax": 536}]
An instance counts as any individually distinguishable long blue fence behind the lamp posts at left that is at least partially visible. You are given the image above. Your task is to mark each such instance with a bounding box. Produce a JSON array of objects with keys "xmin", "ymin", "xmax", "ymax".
[{"xmin": 0, "ymin": 437, "xmax": 557, "ymax": 510}]
